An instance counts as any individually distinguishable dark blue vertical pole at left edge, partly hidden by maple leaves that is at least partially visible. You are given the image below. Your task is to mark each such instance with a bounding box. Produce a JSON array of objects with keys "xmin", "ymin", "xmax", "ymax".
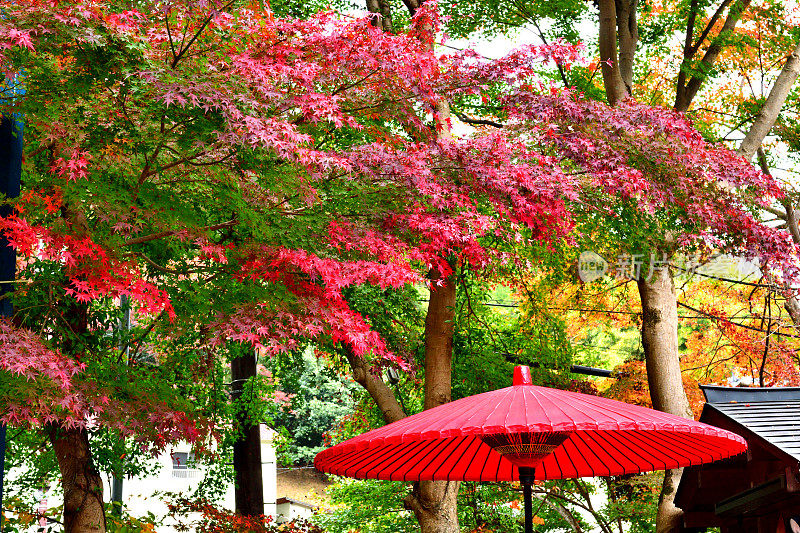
[{"xmin": 0, "ymin": 112, "xmax": 23, "ymax": 530}]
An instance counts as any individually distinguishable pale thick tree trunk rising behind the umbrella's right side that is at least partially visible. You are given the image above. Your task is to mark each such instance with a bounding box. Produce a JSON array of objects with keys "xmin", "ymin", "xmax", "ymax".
[{"xmin": 637, "ymin": 269, "xmax": 692, "ymax": 533}]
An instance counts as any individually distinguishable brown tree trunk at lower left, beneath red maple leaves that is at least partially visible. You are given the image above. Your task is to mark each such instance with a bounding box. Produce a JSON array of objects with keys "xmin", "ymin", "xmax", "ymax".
[{"xmin": 47, "ymin": 426, "xmax": 106, "ymax": 533}]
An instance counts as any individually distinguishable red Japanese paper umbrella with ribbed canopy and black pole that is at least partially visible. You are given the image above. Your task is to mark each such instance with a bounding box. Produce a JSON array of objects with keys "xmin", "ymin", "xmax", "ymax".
[{"xmin": 314, "ymin": 366, "xmax": 747, "ymax": 531}]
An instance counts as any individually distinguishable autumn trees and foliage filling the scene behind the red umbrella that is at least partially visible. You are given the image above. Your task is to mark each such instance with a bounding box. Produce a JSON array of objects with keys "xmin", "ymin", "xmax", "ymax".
[{"xmin": 0, "ymin": 0, "xmax": 800, "ymax": 532}]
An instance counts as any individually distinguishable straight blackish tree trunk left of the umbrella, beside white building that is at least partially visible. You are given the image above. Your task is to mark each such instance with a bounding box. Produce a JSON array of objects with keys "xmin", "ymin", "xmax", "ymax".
[{"xmin": 231, "ymin": 352, "xmax": 264, "ymax": 516}]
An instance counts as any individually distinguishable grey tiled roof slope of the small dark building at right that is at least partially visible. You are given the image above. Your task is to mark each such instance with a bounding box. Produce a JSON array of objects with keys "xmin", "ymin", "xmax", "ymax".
[{"xmin": 703, "ymin": 387, "xmax": 800, "ymax": 461}]
